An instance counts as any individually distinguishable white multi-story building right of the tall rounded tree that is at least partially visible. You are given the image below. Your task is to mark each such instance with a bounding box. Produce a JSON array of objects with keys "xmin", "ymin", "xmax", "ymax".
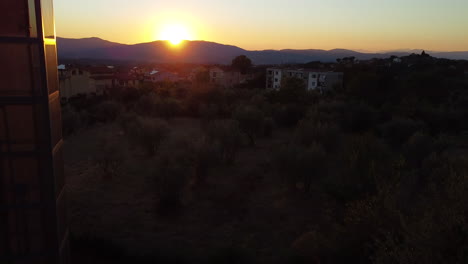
[{"xmin": 266, "ymin": 68, "xmax": 343, "ymax": 91}]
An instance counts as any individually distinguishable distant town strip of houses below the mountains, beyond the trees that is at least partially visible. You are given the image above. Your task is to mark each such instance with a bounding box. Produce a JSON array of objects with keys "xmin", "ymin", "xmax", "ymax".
[{"xmin": 58, "ymin": 57, "xmax": 343, "ymax": 101}]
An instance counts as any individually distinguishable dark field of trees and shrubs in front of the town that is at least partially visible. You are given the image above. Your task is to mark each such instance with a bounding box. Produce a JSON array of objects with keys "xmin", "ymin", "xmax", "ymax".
[{"xmin": 64, "ymin": 55, "xmax": 468, "ymax": 264}]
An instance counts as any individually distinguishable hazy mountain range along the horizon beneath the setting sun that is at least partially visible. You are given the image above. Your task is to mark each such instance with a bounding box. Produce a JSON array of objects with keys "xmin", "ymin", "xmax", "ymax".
[{"xmin": 57, "ymin": 38, "xmax": 468, "ymax": 65}]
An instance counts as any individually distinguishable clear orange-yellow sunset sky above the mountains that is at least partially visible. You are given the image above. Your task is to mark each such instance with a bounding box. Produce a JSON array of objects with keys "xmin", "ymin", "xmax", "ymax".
[{"xmin": 54, "ymin": 0, "xmax": 468, "ymax": 51}]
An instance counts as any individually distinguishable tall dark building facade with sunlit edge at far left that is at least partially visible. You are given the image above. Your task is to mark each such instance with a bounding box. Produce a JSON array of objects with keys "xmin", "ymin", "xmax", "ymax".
[{"xmin": 0, "ymin": 0, "xmax": 69, "ymax": 264}]
